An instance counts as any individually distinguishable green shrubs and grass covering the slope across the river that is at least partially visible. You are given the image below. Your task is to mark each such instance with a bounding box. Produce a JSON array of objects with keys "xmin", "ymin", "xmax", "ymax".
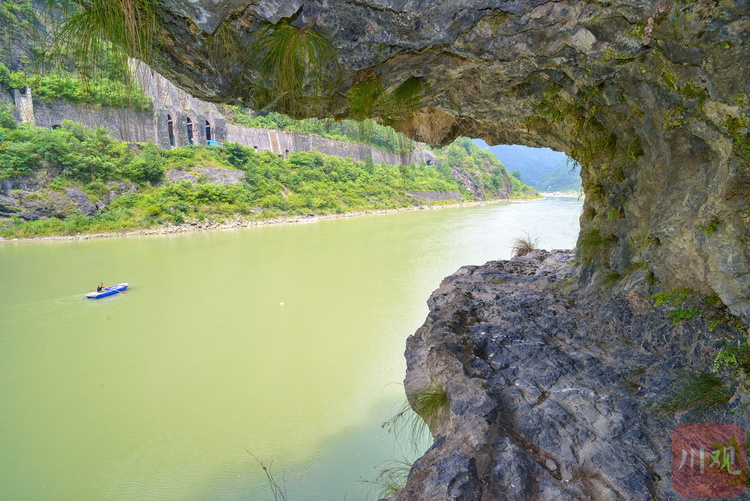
[{"xmin": 0, "ymin": 111, "xmax": 540, "ymax": 237}]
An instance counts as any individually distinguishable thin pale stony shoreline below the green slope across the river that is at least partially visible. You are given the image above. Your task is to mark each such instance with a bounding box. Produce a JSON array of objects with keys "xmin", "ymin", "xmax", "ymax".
[{"xmin": 0, "ymin": 198, "xmax": 528, "ymax": 244}]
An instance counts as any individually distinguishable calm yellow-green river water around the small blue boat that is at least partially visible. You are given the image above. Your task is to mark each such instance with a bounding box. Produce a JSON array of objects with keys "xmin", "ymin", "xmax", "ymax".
[{"xmin": 0, "ymin": 198, "xmax": 581, "ymax": 501}]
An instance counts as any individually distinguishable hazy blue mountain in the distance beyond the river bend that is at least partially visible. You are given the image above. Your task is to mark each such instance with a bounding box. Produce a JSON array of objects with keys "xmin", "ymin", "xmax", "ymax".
[{"xmin": 472, "ymin": 139, "xmax": 581, "ymax": 192}]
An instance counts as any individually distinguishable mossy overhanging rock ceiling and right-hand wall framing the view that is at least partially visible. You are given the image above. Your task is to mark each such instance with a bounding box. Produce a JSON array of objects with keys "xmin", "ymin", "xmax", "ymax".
[{"xmin": 137, "ymin": 0, "xmax": 750, "ymax": 321}]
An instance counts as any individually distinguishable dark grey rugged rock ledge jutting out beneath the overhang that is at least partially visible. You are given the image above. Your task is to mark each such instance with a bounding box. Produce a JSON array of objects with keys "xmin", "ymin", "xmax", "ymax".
[{"xmin": 391, "ymin": 251, "xmax": 749, "ymax": 501}]
